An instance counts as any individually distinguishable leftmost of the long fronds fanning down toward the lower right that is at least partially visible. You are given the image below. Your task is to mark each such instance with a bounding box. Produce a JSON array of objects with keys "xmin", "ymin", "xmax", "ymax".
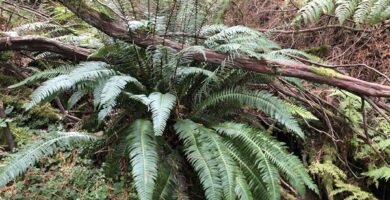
[{"xmin": 174, "ymin": 120, "xmax": 223, "ymax": 200}]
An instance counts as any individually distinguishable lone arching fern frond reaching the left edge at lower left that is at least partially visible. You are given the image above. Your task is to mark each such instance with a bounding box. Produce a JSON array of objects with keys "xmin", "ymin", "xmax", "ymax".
[{"xmin": 0, "ymin": 132, "xmax": 96, "ymax": 186}]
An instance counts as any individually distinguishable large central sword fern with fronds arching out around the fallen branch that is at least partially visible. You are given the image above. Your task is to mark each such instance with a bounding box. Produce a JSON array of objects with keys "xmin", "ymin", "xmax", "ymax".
[{"xmin": 3, "ymin": 22, "xmax": 318, "ymax": 200}]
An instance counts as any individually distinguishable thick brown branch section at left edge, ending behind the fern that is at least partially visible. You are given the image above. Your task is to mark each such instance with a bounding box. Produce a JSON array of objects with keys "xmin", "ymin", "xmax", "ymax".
[{"xmin": 0, "ymin": 36, "xmax": 92, "ymax": 61}]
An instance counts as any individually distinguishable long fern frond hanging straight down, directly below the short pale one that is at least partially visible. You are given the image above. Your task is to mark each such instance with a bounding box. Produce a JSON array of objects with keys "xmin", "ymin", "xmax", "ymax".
[{"xmin": 128, "ymin": 119, "xmax": 159, "ymax": 200}]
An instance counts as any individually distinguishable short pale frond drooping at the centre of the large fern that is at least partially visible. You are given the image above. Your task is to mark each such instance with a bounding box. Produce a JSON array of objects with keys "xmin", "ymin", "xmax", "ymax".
[{"xmin": 149, "ymin": 92, "xmax": 176, "ymax": 136}]
